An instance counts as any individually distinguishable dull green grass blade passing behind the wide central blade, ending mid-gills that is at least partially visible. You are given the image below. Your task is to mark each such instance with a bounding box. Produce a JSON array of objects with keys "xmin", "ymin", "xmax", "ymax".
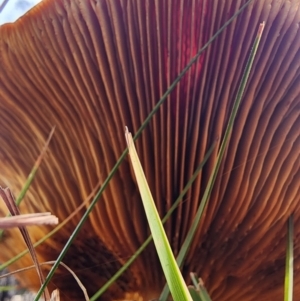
[{"xmin": 90, "ymin": 143, "xmax": 216, "ymax": 301}]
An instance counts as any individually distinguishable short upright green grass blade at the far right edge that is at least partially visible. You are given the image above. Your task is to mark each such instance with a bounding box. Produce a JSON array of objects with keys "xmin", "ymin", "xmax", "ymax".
[{"xmin": 284, "ymin": 216, "xmax": 294, "ymax": 301}]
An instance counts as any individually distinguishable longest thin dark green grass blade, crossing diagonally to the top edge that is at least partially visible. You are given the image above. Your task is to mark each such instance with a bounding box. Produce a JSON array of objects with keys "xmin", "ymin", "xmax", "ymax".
[{"xmin": 34, "ymin": 0, "xmax": 254, "ymax": 301}]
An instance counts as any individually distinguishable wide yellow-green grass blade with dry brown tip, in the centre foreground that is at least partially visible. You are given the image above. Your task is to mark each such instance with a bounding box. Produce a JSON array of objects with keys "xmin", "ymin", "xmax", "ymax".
[{"xmin": 125, "ymin": 127, "xmax": 192, "ymax": 301}]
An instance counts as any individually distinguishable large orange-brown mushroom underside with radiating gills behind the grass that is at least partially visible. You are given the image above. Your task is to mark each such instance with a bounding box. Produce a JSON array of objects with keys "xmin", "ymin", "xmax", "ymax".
[{"xmin": 0, "ymin": 0, "xmax": 300, "ymax": 301}]
